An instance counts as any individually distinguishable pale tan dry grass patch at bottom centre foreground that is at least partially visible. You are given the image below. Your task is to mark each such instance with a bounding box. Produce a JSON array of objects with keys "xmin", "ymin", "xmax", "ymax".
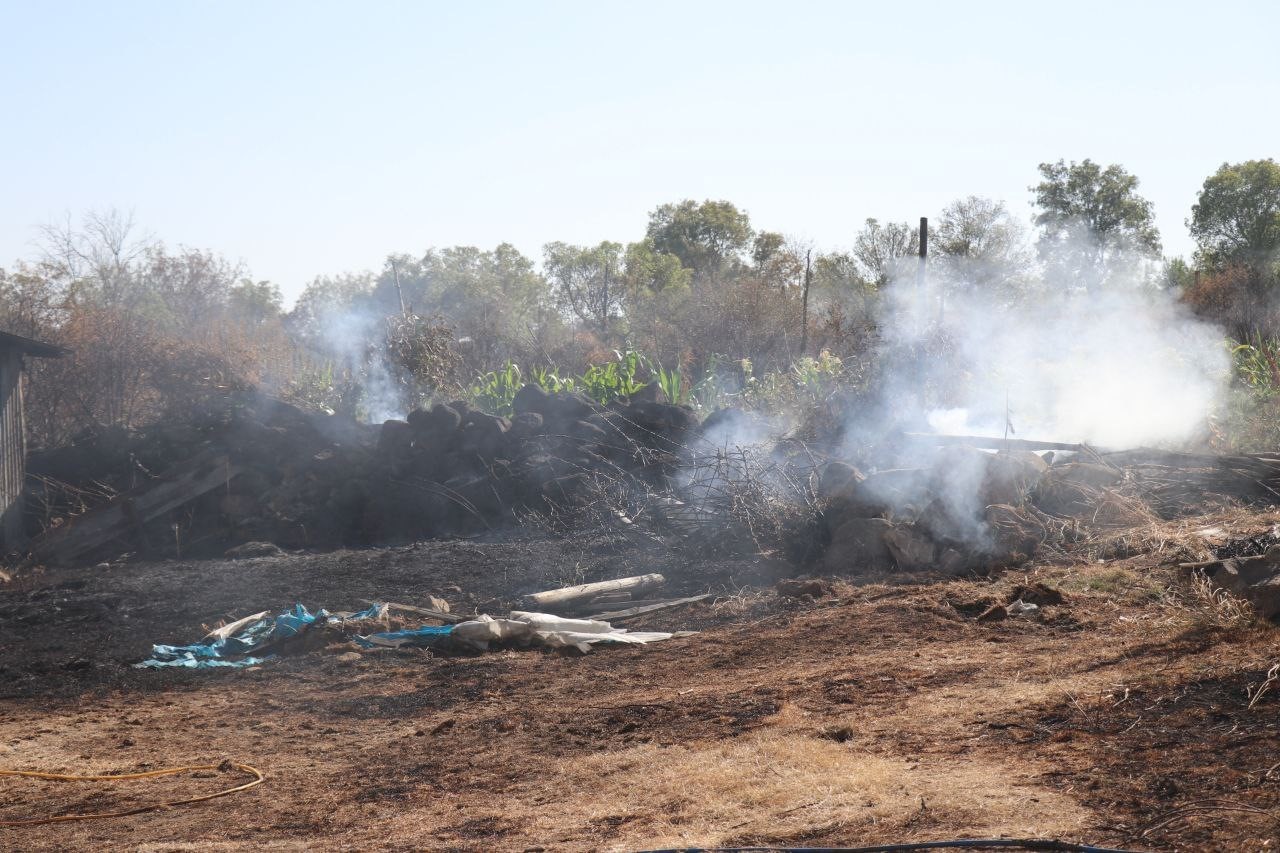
[{"xmin": 519, "ymin": 711, "xmax": 1090, "ymax": 849}]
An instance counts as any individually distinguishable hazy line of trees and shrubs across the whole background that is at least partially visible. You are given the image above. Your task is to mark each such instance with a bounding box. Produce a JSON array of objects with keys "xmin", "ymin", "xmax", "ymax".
[{"xmin": 0, "ymin": 159, "xmax": 1280, "ymax": 443}]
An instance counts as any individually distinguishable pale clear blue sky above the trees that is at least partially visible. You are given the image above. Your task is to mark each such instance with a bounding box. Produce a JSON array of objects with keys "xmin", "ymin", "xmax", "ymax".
[{"xmin": 0, "ymin": 0, "xmax": 1280, "ymax": 301}]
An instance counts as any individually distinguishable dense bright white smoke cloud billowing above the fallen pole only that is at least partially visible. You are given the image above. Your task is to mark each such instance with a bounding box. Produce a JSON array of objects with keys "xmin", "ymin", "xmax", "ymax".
[{"xmin": 879, "ymin": 233, "xmax": 1230, "ymax": 447}]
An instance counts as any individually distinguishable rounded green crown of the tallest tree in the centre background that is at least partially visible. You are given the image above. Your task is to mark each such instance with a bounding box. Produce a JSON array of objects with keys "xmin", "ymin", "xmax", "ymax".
[{"xmin": 645, "ymin": 199, "xmax": 754, "ymax": 280}]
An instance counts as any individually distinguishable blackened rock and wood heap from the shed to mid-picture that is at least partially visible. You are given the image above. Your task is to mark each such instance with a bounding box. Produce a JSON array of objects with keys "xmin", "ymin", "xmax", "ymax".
[{"xmin": 28, "ymin": 386, "xmax": 700, "ymax": 562}]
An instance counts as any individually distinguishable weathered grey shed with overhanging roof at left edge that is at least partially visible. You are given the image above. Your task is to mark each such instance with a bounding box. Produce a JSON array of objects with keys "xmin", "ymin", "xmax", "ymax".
[{"xmin": 0, "ymin": 332, "xmax": 67, "ymax": 552}]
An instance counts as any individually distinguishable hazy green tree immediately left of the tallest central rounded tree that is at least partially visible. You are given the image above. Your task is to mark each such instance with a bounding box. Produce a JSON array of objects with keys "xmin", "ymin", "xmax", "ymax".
[{"xmin": 543, "ymin": 241, "xmax": 625, "ymax": 334}]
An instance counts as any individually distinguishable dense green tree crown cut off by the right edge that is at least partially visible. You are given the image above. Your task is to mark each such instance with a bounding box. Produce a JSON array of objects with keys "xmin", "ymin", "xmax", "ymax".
[{"xmin": 1187, "ymin": 158, "xmax": 1280, "ymax": 273}]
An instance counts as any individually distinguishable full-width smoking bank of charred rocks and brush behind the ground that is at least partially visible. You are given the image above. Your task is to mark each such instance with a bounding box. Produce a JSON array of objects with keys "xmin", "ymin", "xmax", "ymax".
[{"xmin": 27, "ymin": 386, "xmax": 1280, "ymax": 574}]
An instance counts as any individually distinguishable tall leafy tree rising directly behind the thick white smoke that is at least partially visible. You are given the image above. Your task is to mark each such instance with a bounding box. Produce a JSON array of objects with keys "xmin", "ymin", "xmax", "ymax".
[{"xmin": 1030, "ymin": 160, "xmax": 1160, "ymax": 288}]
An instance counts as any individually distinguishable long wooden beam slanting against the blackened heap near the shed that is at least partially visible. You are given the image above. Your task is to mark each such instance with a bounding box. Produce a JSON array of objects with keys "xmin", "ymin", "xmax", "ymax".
[{"xmin": 31, "ymin": 448, "xmax": 243, "ymax": 565}]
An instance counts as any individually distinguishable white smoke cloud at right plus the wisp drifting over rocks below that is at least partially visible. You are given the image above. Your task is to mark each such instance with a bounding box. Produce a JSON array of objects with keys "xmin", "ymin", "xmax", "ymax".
[{"xmin": 845, "ymin": 229, "xmax": 1230, "ymax": 551}]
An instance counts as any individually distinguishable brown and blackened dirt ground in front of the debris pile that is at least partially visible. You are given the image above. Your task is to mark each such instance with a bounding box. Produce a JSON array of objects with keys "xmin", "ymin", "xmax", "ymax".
[{"xmin": 0, "ymin": 514, "xmax": 1280, "ymax": 850}]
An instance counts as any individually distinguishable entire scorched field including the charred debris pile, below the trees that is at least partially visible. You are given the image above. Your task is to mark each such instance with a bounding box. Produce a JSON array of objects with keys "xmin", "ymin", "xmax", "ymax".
[{"xmin": 0, "ymin": 389, "xmax": 1280, "ymax": 850}]
